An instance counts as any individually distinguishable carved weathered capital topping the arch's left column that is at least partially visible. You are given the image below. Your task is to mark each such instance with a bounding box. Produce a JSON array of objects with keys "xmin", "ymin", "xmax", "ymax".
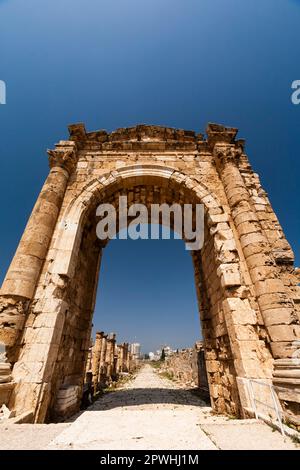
[{"xmin": 47, "ymin": 141, "xmax": 77, "ymax": 175}]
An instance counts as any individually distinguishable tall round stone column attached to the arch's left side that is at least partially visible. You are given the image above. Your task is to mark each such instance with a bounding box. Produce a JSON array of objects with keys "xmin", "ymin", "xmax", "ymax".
[{"xmin": 0, "ymin": 141, "xmax": 77, "ymax": 376}]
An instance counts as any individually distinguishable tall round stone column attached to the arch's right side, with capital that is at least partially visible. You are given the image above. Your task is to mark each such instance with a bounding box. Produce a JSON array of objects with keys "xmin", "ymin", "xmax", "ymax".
[{"xmin": 207, "ymin": 127, "xmax": 300, "ymax": 412}]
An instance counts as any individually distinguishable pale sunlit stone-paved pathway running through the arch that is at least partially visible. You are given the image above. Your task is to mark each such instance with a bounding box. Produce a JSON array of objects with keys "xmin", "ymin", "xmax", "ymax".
[{"xmin": 0, "ymin": 365, "xmax": 296, "ymax": 450}]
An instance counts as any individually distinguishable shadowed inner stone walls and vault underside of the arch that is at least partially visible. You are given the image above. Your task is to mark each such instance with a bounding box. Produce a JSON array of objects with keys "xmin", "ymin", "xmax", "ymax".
[{"xmin": 43, "ymin": 173, "xmax": 240, "ymax": 422}]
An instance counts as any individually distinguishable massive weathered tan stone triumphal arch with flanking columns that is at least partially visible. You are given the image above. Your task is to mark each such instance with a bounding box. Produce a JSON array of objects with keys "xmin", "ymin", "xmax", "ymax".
[{"xmin": 0, "ymin": 124, "xmax": 300, "ymax": 424}]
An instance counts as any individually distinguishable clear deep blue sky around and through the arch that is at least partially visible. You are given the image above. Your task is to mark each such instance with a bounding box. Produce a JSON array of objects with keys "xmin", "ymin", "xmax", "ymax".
[{"xmin": 0, "ymin": 0, "xmax": 300, "ymax": 350}]
